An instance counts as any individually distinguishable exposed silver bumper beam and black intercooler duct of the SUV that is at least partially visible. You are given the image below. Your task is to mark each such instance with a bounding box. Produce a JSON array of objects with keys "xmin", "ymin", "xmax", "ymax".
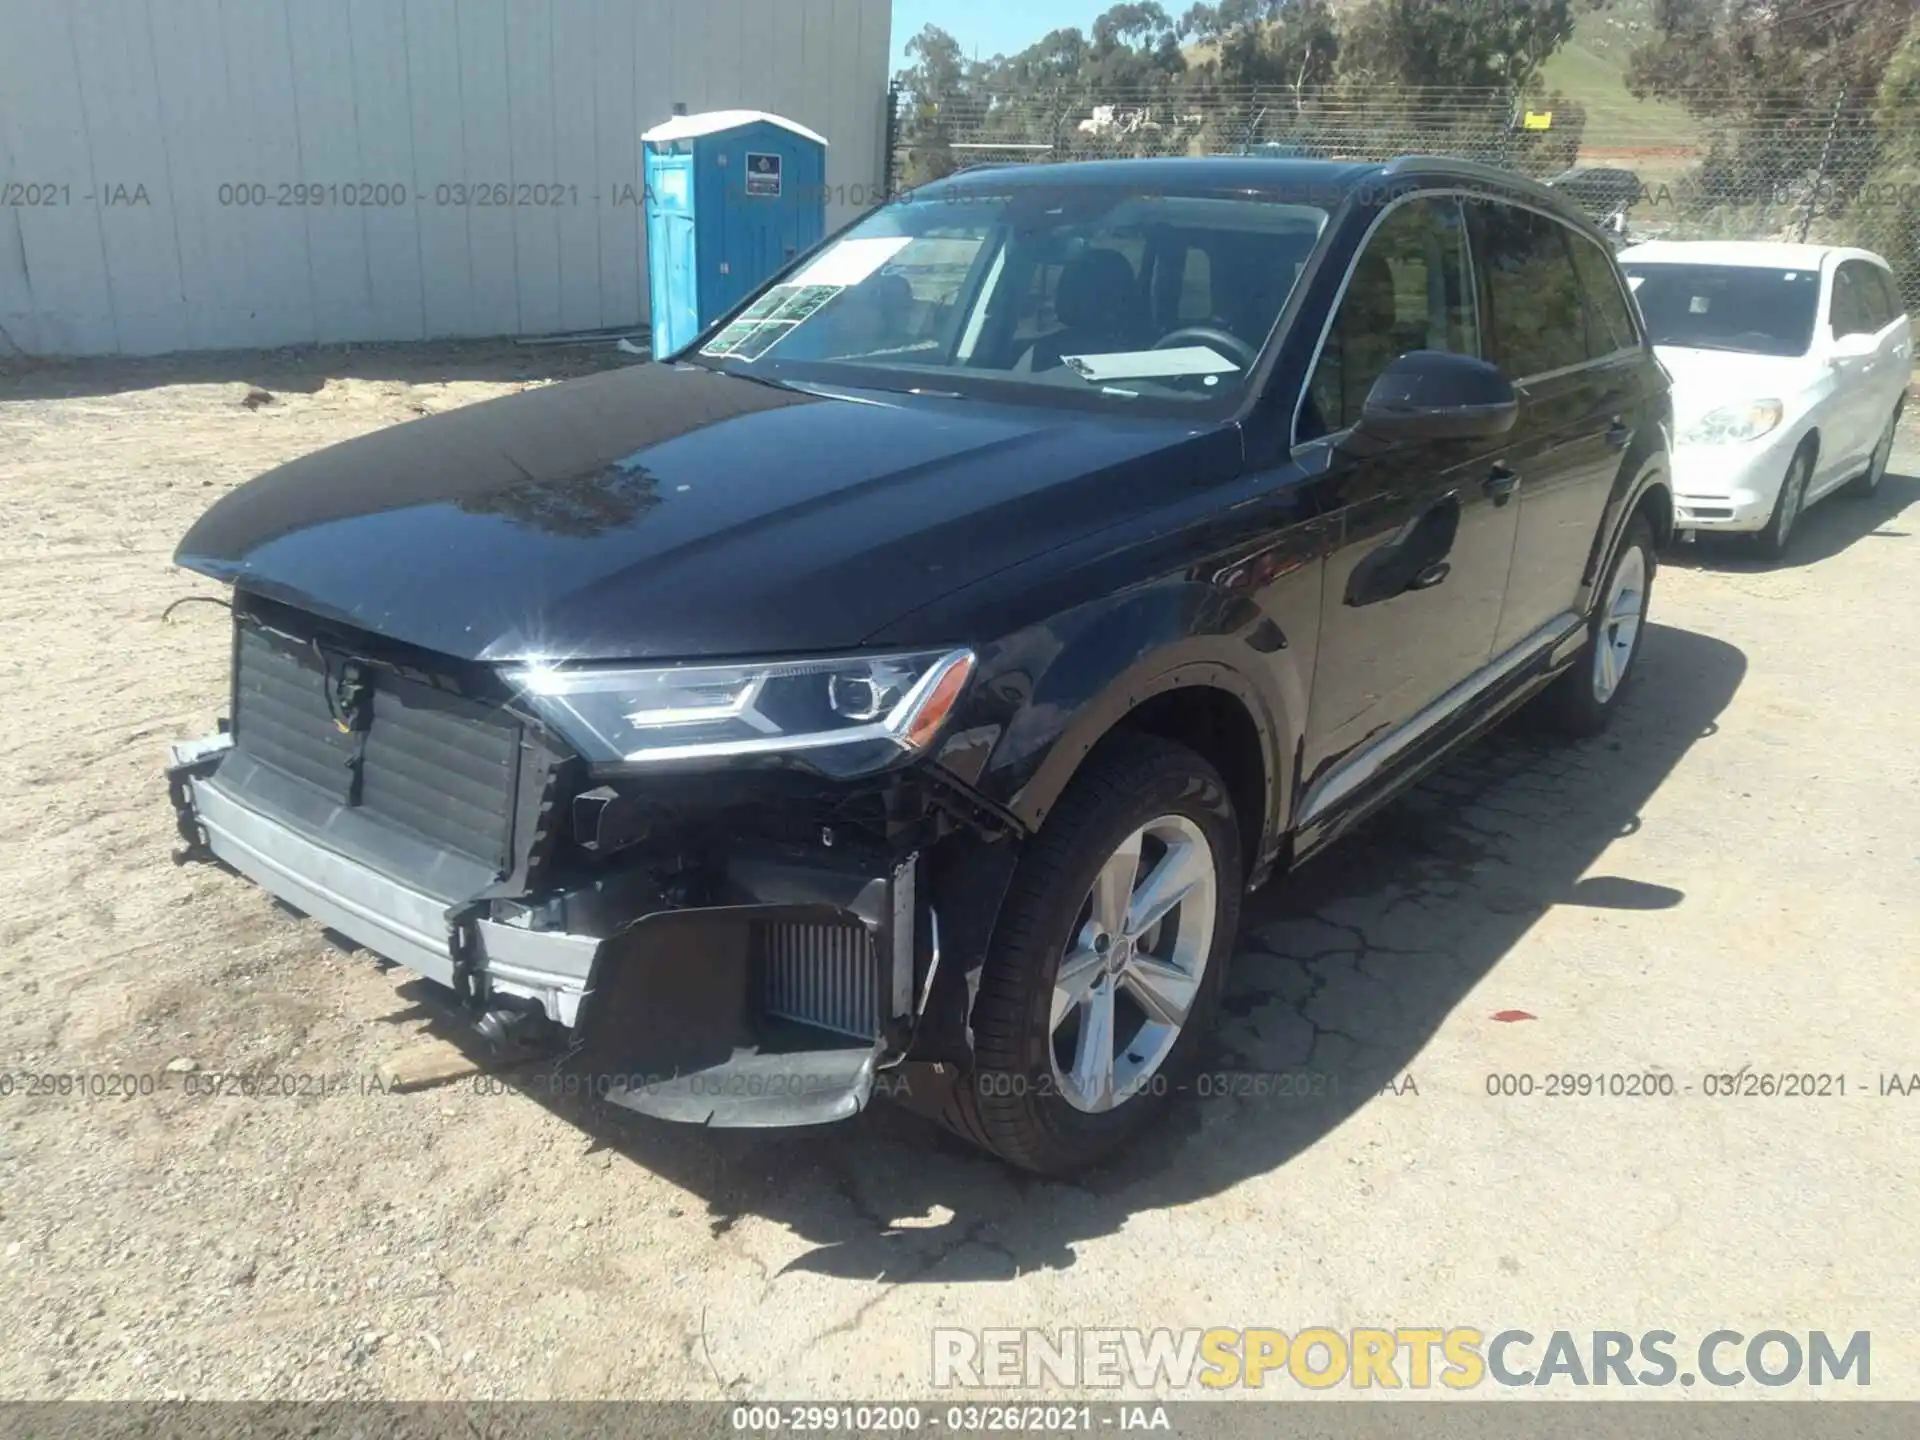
[{"xmin": 167, "ymin": 733, "xmax": 939, "ymax": 1127}]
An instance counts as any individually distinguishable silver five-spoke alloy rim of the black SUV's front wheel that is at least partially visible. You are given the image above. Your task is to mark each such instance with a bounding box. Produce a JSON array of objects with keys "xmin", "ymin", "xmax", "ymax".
[{"xmin": 1048, "ymin": 814, "xmax": 1219, "ymax": 1112}]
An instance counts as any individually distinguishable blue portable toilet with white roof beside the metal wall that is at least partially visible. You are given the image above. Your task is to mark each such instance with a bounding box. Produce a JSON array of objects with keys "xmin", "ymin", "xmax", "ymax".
[{"xmin": 639, "ymin": 109, "xmax": 828, "ymax": 355}]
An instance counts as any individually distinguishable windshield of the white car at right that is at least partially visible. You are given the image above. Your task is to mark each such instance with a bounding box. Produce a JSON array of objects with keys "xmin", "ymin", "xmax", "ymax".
[{"xmin": 1622, "ymin": 263, "xmax": 1820, "ymax": 355}]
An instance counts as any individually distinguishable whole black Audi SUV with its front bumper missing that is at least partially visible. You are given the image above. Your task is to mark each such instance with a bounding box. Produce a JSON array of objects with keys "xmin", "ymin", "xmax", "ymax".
[{"xmin": 169, "ymin": 159, "xmax": 1672, "ymax": 1173}]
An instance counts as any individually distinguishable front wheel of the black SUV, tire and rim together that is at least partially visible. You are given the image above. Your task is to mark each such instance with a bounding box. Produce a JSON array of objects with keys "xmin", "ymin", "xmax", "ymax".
[{"xmin": 945, "ymin": 732, "xmax": 1244, "ymax": 1175}]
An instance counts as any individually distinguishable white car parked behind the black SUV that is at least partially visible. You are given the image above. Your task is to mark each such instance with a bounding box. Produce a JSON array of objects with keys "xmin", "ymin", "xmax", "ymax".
[{"xmin": 1620, "ymin": 240, "xmax": 1912, "ymax": 559}]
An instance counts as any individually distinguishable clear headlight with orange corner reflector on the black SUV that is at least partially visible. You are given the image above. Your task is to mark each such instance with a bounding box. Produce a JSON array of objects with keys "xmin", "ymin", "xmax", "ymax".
[{"xmin": 509, "ymin": 651, "xmax": 973, "ymax": 774}]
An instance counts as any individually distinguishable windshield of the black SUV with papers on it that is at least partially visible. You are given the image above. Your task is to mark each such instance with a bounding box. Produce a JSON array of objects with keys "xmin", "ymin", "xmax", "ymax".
[{"xmin": 684, "ymin": 186, "xmax": 1327, "ymax": 409}]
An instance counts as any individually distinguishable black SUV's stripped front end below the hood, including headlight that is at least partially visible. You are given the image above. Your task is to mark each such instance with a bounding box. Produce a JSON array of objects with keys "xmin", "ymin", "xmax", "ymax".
[{"xmin": 169, "ymin": 591, "xmax": 1020, "ymax": 1125}]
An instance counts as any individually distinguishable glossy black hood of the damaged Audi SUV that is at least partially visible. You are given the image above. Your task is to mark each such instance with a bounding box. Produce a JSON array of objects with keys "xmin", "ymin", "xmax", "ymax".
[{"xmin": 175, "ymin": 365, "xmax": 1238, "ymax": 660}]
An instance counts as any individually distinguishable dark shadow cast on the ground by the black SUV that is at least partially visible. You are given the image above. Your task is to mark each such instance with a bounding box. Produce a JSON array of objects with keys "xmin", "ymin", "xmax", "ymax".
[{"xmin": 445, "ymin": 626, "xmax": 1745, "ymax": 1284}]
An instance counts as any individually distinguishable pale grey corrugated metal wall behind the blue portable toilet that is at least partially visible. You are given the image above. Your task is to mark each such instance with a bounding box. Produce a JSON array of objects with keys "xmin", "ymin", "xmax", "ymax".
[{"xmin": 0, "ymin": 0, "xmax": 891, "ymax": 355}]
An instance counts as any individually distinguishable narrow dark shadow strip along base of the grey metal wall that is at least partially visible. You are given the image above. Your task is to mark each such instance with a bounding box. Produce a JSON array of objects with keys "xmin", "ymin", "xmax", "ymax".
[{"xmin": 0, "ymin": 334, "xmax": 645, "ymax": 401}]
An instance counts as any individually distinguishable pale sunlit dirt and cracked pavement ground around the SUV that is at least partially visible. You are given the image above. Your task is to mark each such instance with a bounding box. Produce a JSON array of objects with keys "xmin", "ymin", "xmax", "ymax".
[{"xmin": 0, "ymin": 346, "xmax": 1920, "ymax": 1398}]
